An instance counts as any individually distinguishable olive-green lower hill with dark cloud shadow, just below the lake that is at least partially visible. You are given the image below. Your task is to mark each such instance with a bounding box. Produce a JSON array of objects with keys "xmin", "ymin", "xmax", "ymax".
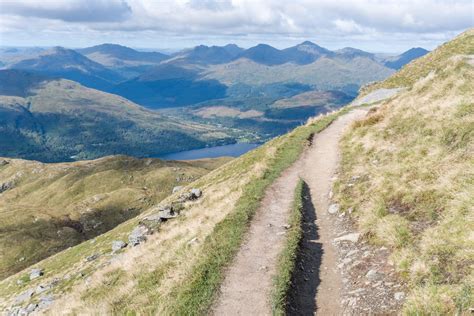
[{"xmin": 0, "ymin": 156, "xmax": 228, "ymax": 279}]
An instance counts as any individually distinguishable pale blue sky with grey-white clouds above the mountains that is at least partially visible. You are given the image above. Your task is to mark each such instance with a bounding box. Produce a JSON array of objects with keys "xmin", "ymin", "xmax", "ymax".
[{"xmin": 0, "ymin": 0, "xmax": 474, "ymax": 52}]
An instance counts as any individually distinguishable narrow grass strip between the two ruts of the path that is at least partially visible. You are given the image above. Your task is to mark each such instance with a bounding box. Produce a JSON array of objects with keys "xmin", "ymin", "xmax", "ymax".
[{"xmin": 272, "ymin": 179, "xmax": 304, "ymax": 315}]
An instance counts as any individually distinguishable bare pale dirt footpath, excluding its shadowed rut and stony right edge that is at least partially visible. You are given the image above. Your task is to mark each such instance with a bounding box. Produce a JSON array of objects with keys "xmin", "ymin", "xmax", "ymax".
[{"xmin": 213, "ymin": 110, "xmax": 366, "ymax": 315}]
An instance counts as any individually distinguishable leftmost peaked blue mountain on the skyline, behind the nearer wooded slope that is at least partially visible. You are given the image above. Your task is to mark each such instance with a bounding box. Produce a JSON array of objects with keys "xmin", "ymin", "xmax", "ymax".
[{"xmin": 9, "ymin": 47, "xmax": 123, "ymax": 90}]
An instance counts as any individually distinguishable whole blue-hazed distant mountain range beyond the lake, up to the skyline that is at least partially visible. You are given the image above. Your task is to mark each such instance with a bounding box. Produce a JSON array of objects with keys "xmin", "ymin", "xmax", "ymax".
[{"xmin": 0, "ymin": 41, "xmax": 426, "ymax": 161}]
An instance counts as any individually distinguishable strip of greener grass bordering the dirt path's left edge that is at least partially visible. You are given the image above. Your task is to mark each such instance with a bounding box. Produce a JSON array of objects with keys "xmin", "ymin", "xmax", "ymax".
[{"xmin": 167, "ymin": 109, "xmax": 347, "ymax": 315}]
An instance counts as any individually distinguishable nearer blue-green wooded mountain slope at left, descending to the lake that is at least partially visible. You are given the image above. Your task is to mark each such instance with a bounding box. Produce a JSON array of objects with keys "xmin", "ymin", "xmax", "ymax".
[{"xmin": 0, "ymin": 70, "xmax": 233, "ymax": 161}]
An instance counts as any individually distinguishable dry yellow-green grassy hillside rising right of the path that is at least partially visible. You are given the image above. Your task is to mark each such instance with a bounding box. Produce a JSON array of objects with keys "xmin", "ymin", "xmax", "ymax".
[{"xmin": 336, "ymin": 30, "xmax": 474, "ymax": 315}]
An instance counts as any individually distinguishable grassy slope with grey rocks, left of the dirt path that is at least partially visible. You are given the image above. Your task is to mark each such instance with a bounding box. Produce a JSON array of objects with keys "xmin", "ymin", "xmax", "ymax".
[{"xmin": 0, "ymin": 104, "xmax": 342, "ymax": 315}]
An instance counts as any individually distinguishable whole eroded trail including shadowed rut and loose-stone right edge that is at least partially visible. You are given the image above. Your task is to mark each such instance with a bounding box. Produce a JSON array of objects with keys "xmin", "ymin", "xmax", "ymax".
[{"xmin": 213, "ymin": 109, "xmax": 404, "ymax": 315}]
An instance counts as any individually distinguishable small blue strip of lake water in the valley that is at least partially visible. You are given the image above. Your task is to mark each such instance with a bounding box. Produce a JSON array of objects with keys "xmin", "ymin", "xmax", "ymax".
[{"xmin": 157, "ymin": 143, "xmax": 260, "ymax": 160}]
